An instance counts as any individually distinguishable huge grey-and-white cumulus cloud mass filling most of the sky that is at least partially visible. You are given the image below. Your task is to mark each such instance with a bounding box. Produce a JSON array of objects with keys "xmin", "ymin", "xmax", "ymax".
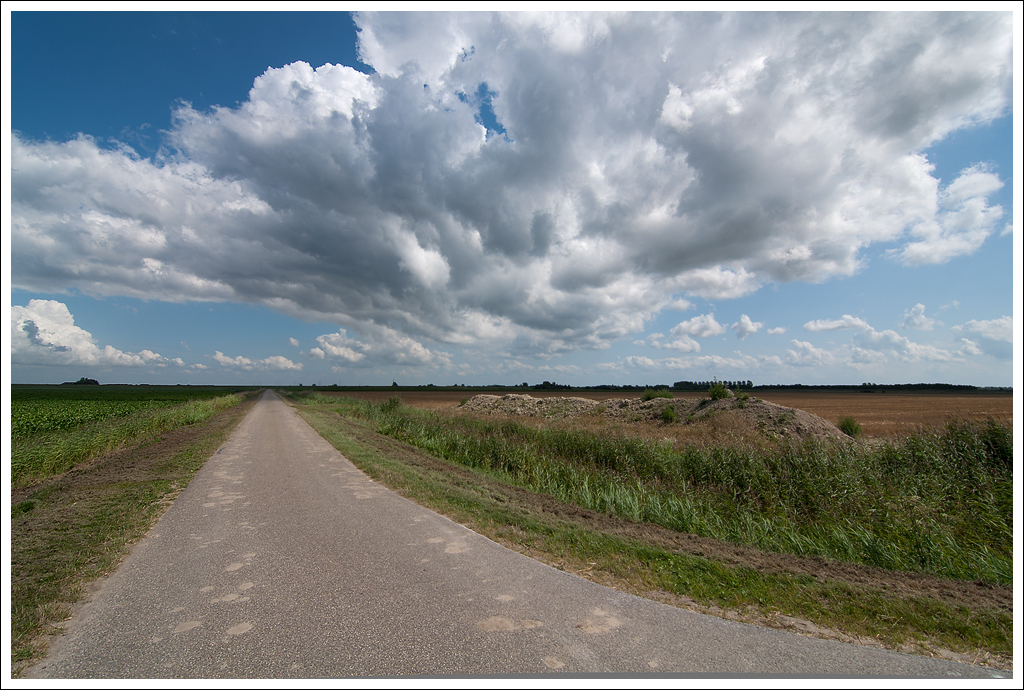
[{"xmin": 12, "ymin": 12, "xmax": 1012, "ymax": 354}]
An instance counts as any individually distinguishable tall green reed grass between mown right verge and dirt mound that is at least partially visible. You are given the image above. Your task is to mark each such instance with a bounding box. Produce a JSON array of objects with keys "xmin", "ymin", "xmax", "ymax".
[{"xmin": 331, "ymin": 398, "xmax": 1013, "ymax": 584}]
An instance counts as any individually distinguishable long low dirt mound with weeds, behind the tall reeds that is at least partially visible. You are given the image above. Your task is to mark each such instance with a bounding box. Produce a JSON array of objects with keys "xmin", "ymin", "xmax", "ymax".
[{"xmin": 460, "ymin": 393, "xmax": 849, "ymax": 441}]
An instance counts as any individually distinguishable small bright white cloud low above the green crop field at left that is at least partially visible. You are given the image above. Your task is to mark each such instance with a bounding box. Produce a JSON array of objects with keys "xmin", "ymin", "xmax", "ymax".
[{"xmin": 10, "ymin": 300, "xmax": 185, "ymax": 368}]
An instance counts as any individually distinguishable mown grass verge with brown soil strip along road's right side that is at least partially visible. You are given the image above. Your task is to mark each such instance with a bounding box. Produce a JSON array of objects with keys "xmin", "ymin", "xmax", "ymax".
[{"xmin": 298, "ymin": 400, "xmax": 1013, "ymax": 667}]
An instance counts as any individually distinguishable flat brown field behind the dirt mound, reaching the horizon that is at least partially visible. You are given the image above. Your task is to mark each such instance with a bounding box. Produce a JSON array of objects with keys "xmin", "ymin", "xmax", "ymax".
[{"xmin": 322, "ymin": 389, "xmax": 1014, "ymax": 437}]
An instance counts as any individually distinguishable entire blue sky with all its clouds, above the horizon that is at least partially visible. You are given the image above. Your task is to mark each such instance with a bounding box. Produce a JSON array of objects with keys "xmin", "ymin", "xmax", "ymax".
[{"xmin": 3, "ymin": 8, "xmax": 1021, "ymax": 386}]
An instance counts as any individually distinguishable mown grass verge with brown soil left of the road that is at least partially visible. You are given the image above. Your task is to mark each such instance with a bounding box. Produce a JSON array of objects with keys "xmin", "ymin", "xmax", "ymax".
[{"xmin": 10, "ymin": 395, "xmax": 256, "ymax": 676}]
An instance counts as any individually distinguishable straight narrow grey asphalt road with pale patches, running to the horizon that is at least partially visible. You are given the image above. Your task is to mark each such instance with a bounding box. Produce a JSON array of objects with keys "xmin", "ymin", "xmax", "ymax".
[{"xmin": 28, "ymin": 392, "xmax": 1009, "ymax": 678}]
